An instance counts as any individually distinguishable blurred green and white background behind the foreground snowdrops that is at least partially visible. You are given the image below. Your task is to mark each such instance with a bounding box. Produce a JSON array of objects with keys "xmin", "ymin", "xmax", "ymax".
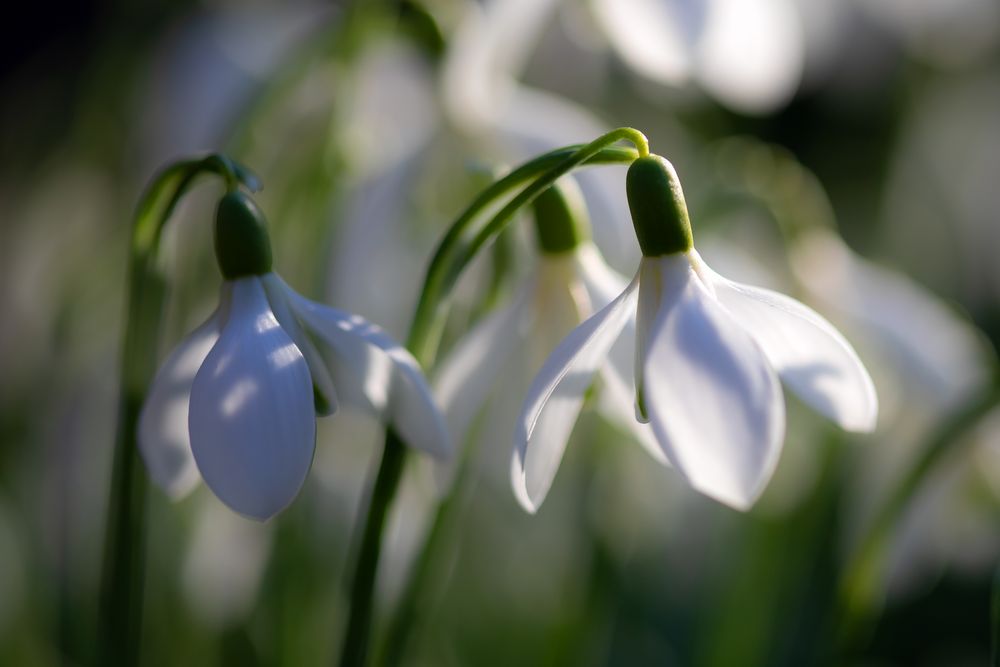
[{"xmin": 0, "ymin": 0, "xmax": 1000, "ymax": 665}]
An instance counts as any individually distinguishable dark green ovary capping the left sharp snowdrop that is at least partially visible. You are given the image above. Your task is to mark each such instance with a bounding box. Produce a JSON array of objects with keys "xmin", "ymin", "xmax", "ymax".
[{"xmin": 215, "ymin": 190, "xmax": 271, "ymax": 280}]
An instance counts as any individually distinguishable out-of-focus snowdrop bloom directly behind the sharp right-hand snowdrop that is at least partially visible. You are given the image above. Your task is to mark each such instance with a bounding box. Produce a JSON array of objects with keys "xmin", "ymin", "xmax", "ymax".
[{"xmin": 434, "ymin": 177, "xmax": 665, "ymax": 482}]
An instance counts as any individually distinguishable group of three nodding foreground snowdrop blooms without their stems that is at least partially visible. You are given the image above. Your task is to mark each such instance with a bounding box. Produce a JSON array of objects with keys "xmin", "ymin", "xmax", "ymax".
[{"xmin": 139, "ymin": 156, "xmax": 878, "ymax": 520}]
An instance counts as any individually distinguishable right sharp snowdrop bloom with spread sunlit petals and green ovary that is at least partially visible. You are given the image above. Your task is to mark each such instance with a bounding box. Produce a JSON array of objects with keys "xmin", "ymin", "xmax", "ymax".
[{"xmin": 514, "ymin": 156, "xmax": 878, "ymax": 510}]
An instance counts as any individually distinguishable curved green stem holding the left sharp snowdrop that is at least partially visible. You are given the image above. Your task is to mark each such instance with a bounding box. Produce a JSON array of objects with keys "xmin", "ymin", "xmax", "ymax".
[{"xmin": 96, "ymin": 154, "xmax": 259, "ymax": 665}]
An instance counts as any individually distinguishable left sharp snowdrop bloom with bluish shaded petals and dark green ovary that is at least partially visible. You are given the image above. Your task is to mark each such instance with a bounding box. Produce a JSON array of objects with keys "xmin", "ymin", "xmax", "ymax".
[{"xmin": 139, "ymin": 192, "xmax": 449, "ymax": 520}]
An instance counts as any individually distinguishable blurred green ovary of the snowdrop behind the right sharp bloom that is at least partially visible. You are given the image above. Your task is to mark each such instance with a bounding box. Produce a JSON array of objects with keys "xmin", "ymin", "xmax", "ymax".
[{"xmin": 532, "ymin": 178, "xmax": 590, "ymax": 255}]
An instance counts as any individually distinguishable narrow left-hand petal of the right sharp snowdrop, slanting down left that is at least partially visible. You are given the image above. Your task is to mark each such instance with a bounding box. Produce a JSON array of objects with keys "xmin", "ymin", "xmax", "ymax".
[{"xmin": 512, "ymin": 280, "xmax": 638, "ymax": 512}]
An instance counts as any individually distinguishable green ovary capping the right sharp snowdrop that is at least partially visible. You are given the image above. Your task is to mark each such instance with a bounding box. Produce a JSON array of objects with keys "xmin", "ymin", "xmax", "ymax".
[{"xmin": 625, "ymin": 155, "xmax": 694, "ymax": 257}]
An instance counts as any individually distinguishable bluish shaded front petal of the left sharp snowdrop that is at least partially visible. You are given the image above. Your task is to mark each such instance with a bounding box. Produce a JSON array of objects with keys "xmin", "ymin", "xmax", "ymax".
[{"xmin": 189, "ymin": 277, "xmax": 316, "ymax": 521}]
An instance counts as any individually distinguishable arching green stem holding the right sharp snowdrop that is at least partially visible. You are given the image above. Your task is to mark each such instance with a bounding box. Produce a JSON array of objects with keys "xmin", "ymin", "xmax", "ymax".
[{"xmin": 340, "ymin": 128, "xmax": 649, "ymax": 667}]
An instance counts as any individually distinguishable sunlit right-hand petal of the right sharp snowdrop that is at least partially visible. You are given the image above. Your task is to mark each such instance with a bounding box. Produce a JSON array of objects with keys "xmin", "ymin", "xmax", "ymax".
[{"xmin": 713, "ymin": 268, "xmax": 878, "ymax": 432}]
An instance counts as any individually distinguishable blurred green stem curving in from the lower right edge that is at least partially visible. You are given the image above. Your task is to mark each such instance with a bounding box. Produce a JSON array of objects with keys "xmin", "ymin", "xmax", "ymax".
[{"xmin": 834, "ymin": 372, "xmax": 1000, "ymax": 651}]
